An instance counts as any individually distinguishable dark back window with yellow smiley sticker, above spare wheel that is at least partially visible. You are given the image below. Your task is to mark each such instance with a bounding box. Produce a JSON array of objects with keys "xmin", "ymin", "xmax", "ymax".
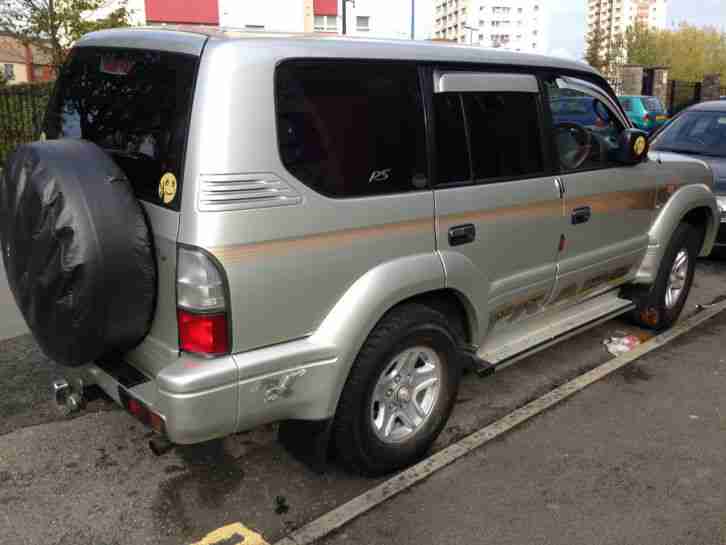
[{"xmin": 45, "ymin": 48, "xmax": 198, "ymax": 210}]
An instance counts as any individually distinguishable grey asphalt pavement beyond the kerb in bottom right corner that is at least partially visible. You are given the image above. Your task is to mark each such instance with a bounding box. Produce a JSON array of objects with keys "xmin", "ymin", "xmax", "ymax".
[{"xmin": 324, "ymin": 314, "xmax": 726, "ymax": 545}]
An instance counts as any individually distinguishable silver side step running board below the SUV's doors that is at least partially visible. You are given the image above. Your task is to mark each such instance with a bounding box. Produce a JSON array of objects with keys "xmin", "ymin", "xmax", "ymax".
[{"xmin": 472, "ymin": 294, "xmax": 635, "ymax": 376}]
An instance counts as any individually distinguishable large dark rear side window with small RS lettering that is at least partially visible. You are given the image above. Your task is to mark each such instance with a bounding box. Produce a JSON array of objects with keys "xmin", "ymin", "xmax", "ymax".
[{"xmin": 277, "ymin": 61, "xmax": 427, "ymax": 197}]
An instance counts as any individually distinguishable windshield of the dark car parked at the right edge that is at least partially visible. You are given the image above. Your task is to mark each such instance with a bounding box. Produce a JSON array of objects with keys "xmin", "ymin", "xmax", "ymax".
[{"xmin": 651, "ymin": 108, "xmax": 726, "ymax": 157}]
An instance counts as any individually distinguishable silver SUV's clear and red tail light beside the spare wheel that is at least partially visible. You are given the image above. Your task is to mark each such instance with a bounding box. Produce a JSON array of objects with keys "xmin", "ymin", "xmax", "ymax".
[{"xmin": 177, "ymin": 246, "xmax": 230, "ymax": 356}]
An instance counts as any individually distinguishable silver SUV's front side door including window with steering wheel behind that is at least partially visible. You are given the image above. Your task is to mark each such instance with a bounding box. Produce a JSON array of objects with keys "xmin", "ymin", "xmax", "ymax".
[{"xmin": 545, "ymin": 77, "xmax": 657, "ymax": 303}]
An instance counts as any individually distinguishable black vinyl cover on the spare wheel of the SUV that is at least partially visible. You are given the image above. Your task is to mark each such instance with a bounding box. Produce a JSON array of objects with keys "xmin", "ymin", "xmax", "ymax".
[{"xmin": 0, "ymin": 140, "xmax": 157, "ymax": 367}]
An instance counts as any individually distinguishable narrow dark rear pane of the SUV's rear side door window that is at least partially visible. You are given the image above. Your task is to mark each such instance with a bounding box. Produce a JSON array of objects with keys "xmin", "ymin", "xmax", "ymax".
[{"xmin": 434, "ymin": 93, "xmax": 471, "ymax": 183}]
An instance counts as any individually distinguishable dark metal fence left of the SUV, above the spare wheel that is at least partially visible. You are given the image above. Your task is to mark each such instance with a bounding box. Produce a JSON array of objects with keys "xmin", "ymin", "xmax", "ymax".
[{"xmin": 0, "ymin": 83, "xmax": 53, "ymax": 167}]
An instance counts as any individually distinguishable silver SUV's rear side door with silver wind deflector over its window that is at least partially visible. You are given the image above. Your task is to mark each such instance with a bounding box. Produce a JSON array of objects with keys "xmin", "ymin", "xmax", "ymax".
[{"xmin": 432, "ymin": 71, "xmax": 562, "ymax": 334}]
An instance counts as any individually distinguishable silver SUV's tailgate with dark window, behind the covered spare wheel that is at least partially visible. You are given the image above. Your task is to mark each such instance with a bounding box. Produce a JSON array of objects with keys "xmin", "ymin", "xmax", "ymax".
[{"xmin": 45, "ymin": 30, "xmax": 207, "ymax": 377}]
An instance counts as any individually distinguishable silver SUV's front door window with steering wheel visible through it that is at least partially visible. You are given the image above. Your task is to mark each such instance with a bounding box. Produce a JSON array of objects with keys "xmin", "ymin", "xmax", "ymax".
[{"xmin": 546, "ymin": 81, "xmax": 625, "ymax": 172}]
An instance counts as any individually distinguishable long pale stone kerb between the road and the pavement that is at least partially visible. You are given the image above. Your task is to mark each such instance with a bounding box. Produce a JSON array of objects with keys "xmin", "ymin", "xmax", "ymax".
[{"xmin": 272, "ymin": 301, "xmax": 726, "ymax": 545}]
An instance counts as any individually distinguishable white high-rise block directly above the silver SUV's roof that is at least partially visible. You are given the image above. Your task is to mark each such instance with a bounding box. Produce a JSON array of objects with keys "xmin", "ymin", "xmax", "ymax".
[{"xmin": 433, "ymin": 0, "xmax": 548, "ymax": 53}]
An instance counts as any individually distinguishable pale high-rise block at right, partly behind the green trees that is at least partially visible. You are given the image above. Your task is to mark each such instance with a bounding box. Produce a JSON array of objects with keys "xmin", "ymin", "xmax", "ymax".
[{"xmin": 587, "ymin": 0, "xmax": 668, "ymax": 42}]
